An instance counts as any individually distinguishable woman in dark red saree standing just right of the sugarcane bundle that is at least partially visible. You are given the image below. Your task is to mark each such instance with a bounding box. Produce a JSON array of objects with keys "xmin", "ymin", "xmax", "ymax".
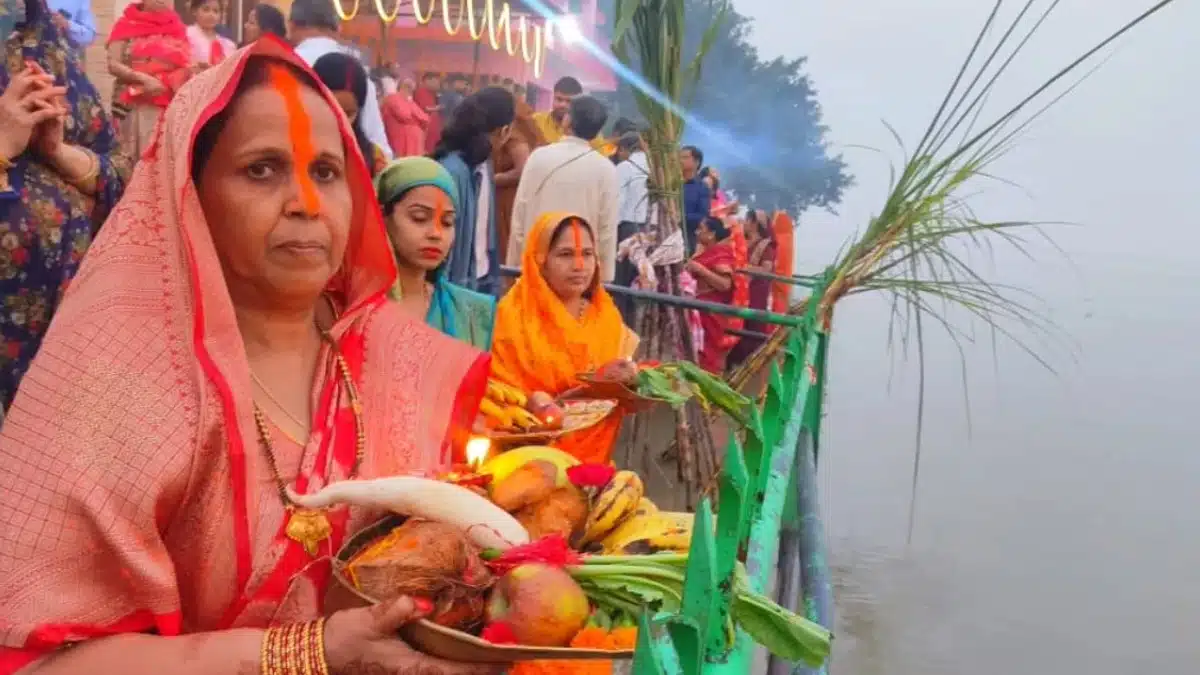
[{"xmin": 686, "ymin": 216, "xmax": 750, "ymax": 375}]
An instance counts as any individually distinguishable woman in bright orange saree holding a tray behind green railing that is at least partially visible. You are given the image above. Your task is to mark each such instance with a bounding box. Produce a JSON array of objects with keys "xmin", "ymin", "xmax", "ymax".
[{"xmin": 492, "ymin": 213, "xmax": 638, "ymax": 464}]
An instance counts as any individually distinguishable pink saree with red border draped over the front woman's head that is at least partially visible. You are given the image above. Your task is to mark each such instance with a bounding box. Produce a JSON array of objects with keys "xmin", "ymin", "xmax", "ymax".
[{"xmin": 0, "ymin": 40, "xmax": 488, "ymax": 674}]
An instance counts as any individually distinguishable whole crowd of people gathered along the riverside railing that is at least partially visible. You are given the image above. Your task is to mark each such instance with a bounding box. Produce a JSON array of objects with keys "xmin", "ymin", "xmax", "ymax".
[{"xmin": 0, "ymin": 0, "xmax": 791, "ymax": 675}]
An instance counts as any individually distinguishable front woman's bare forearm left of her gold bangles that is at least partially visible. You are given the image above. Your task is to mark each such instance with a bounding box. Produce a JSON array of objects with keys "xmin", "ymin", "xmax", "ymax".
[{"xmin": 19, "ymin": 628, "xmax": 264, "ymax": 675}]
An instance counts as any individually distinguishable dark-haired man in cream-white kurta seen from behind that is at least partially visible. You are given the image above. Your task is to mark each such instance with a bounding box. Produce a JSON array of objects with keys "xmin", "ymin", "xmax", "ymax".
[{"xmin": 504, "ymin": 96, "xmax": 619, "ymax": 281}]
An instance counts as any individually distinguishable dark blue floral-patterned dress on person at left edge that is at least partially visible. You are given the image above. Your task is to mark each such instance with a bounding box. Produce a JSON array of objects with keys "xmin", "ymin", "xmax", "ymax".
[{"xmin": 0, "ymin": 0, "xmax": 130, "ymax": 408}]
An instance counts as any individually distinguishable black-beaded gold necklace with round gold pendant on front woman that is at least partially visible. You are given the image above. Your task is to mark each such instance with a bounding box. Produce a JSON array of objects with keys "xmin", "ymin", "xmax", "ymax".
[{"xmin": 254, "ymin": 331, "xmax": 367, "ymax": 556}]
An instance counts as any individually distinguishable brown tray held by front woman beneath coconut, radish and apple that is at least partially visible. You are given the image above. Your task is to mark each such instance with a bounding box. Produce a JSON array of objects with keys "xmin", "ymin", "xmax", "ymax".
[{"xmin": 334, "ymin": 515, "xmax": 634, "ymax": 664}]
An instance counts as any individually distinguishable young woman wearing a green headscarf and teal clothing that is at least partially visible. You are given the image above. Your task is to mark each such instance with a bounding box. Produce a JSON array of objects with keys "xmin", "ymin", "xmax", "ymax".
[{"xmin": 376, "ymin": 157, "xmax": 496, "ymax": 351}]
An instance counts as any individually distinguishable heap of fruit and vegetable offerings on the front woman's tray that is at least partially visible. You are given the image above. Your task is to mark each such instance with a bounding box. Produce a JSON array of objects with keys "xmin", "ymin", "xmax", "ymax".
[{"xmin": 294, "ymin": 446, "xmax": 829, "ymax": 663}]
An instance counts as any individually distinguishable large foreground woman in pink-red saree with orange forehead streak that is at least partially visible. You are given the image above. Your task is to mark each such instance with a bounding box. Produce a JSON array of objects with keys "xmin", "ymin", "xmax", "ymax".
[{"xmin": 0, "ymin": 37, "xmax": 497, "ymax": 675}]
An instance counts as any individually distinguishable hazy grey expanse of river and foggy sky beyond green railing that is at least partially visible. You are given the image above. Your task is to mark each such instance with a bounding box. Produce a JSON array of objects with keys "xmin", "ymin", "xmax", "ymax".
[{"xmin": 736, "ymin": 0, "xmax": 1200, "ymax": 675}]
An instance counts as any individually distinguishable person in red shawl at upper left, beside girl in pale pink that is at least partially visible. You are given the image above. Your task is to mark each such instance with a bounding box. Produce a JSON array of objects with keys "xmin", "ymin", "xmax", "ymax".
[{"xmin": 108, "ymin": 0, "xmax": 192, "ymax": 161}]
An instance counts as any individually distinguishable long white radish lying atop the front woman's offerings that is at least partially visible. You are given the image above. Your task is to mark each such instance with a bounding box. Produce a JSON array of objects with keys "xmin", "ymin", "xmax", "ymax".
[{"xmin": 288, "ymin": 476, "xmax": 529, "ymax": 550}]
